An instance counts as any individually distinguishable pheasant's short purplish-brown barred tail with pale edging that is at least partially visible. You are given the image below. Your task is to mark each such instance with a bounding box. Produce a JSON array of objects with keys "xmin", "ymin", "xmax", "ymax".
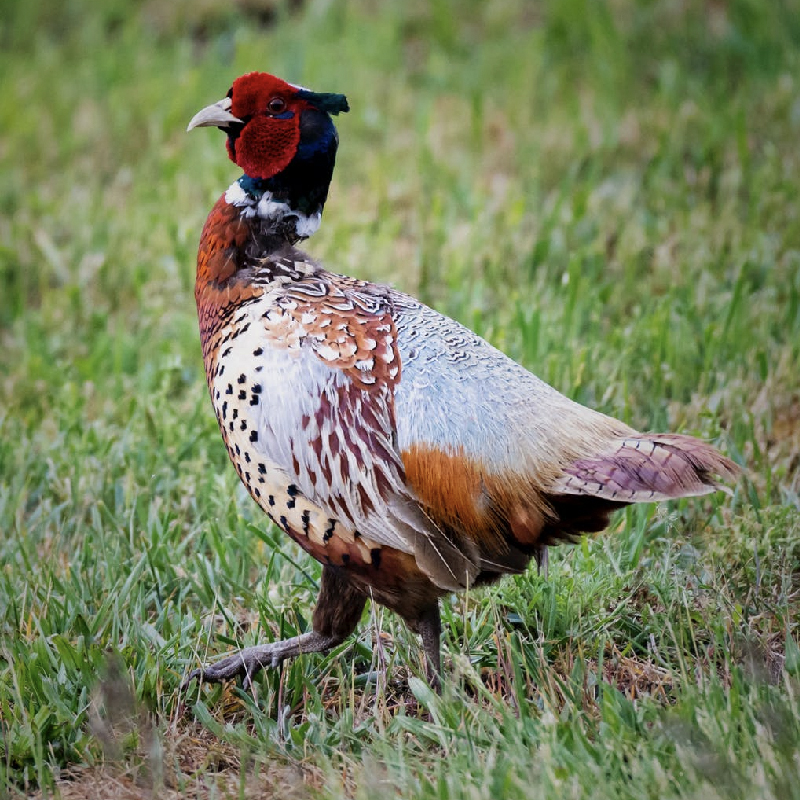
[{"xmin": 551, "ymin": 433, "xmax": 739, "ymax": 503}]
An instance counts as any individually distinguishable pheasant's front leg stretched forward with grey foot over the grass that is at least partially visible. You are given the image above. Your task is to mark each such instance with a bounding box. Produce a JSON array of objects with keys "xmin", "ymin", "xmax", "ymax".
[{"xmin": 181, "ymin": 566, "xmax": 367, "ymax": 690}]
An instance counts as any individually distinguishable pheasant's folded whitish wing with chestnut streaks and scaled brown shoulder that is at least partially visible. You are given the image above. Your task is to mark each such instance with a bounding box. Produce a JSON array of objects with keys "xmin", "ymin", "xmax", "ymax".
[{"xmin": 242, "ymin": 260, "xmax": 478, "ymax": 590}]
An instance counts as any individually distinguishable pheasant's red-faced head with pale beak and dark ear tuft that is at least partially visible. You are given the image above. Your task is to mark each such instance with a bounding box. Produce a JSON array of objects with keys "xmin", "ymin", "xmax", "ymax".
[{"xmin": 187, "ymin": 72, "xmax": 349, "ymax": 180}]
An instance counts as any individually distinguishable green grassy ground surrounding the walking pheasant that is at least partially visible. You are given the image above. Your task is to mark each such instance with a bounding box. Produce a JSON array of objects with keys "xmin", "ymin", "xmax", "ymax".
[{"xmin": 0, "ymin": 0, "xmax": 800, "ymax": 800}]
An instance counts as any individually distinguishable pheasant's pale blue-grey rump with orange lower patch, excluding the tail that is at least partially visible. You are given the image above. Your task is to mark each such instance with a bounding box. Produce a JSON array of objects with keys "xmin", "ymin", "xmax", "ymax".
[{"xmin": 393, "ymin": 293, "xmax": 635, "ymax": 536}]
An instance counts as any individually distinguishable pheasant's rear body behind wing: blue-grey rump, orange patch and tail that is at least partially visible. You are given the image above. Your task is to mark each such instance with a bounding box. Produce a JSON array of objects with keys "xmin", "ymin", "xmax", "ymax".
[{"xmin": 393, "ymin": 293, "xmax": 736, "ymax": 569}]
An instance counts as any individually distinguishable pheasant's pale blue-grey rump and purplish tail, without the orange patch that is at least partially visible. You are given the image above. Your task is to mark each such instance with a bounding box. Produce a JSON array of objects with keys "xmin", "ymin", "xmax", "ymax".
[{"xmin": 393, "ymin": 294, "xmax": 738, "ymax": 502}]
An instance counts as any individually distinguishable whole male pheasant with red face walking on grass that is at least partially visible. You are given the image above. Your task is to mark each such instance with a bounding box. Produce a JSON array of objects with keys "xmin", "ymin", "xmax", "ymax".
[{"xmin": 186, "ymin": 72, "xmax": 736, "ymax": 687}]
